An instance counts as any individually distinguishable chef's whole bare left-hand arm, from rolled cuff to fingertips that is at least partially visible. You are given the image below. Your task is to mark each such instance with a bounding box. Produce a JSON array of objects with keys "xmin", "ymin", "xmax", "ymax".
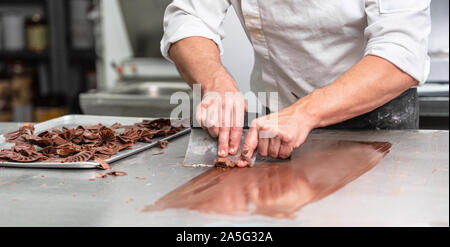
[{"xmin": 169, "ymin": 37, "xmax": 246, "ymax": 157}]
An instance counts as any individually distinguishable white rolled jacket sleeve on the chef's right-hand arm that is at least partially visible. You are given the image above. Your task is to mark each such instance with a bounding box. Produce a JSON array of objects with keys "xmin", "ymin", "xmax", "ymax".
[{"xmin": 364, "ymin": 0, "xmax": 431, "ymax": 84}]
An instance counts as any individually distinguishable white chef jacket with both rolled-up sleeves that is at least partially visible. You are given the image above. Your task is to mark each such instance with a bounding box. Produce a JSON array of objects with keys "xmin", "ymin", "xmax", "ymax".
[{"xmin": 161, "ymin": 0, "xmax": 431, "ymax": 109}]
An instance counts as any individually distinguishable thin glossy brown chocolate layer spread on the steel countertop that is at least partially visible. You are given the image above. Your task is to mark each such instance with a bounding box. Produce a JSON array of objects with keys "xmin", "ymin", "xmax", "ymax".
[{"xmin": 142, "ymin": 139, "xmax": 391, "ymax": 218}]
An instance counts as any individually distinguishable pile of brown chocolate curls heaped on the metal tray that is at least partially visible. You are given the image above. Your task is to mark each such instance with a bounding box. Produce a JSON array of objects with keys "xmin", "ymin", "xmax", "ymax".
[{"xmin": 0, "ymin": 119, "xmax": 182, "ymax": 169}]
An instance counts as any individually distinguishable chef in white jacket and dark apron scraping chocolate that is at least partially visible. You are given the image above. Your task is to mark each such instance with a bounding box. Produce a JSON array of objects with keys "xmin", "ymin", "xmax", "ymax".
[{"xmin": 161, "ymin": 0, "xmax": 431, "ymax": 166}]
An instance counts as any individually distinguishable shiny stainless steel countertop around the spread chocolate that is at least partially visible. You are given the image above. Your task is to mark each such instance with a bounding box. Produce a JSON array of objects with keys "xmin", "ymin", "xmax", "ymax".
[{"xmin": 0, "ymin": 123, "xmax": 449, "ymax": 226}]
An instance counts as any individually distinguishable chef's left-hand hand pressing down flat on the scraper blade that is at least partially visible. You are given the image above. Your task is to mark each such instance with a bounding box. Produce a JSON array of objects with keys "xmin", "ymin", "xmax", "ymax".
[{"xmin": 196, "ymin": 72, "xmax": 247, "ymax": 157}]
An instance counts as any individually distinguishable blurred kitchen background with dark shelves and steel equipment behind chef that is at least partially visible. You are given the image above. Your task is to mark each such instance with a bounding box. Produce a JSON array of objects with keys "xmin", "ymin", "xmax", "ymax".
[{"xmin": 0, "ymin": 0, "xmax": 449, "ymax": 129}]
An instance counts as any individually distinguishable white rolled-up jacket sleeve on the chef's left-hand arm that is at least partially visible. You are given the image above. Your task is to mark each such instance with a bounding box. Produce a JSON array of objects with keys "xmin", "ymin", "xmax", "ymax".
[{"xmin": 161, "ymin": 0, "xmax": 231, "ymax": 61}]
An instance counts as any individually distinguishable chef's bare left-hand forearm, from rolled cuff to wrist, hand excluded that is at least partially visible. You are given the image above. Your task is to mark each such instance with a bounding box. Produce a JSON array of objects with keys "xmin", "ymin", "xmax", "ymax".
[{"xmin": 169, "ymin": 37, "xmax": 237, "ymax": 92}]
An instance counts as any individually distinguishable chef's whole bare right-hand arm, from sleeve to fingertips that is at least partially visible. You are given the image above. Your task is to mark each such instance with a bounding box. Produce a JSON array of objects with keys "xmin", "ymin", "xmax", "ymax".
[{"xmin": 239, "ymin": 55, "xmax": 417, "ymax": 166}]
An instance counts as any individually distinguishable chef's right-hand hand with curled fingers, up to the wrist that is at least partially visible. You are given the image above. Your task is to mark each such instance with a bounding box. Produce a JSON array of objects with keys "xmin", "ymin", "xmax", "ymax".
[{"xmin": 238, "ymin": 105, "xmax": 318, "ymax": 167}]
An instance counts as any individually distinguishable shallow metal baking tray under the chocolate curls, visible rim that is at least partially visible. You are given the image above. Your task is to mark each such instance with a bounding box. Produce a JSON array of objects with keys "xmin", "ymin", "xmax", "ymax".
[{"xmin": 0, "ymin": 115, "xmax": 191, "ymax": 168}]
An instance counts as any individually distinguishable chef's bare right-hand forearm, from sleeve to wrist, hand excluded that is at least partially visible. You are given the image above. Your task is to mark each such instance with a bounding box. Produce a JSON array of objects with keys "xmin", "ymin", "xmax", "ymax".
[{"xmin": 294, "ymin": 56, "xmax": 417, "ymax": 127}]
